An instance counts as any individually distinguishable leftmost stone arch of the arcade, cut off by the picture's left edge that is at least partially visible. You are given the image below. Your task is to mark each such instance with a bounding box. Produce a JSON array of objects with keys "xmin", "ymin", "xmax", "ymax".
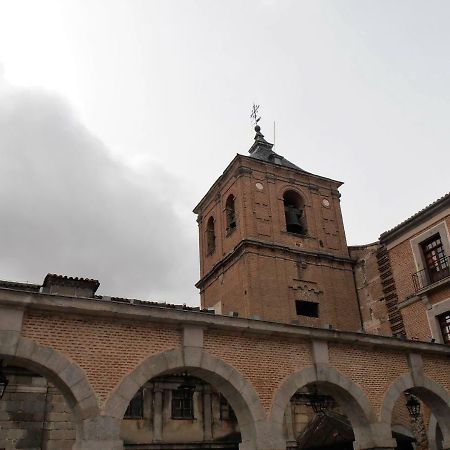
[{"xmin": 0, "ymin": 331, "xmax": 100, "ymax": 448}]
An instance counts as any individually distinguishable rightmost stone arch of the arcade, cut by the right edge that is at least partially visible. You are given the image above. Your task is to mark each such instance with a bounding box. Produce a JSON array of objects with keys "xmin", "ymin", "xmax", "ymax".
[{"xmin": 380, "ymin": 373, "xmax": 450, "ymax": 445}]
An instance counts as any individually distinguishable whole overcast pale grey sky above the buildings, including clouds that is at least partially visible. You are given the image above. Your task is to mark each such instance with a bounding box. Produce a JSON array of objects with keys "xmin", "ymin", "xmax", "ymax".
[{"xmin": 0, "ymin": 0, "xmax": 450, "ymax": 305}]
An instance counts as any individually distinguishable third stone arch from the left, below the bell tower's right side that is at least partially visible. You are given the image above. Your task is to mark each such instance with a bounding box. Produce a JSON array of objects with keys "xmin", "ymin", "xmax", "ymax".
[{"xmin": 270, "ymin": 365, "xmax": 393, "ymax": 449}]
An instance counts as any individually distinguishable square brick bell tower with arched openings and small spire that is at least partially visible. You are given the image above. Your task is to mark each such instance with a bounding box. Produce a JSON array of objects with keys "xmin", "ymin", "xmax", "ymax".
[{"xmin": 194, "ymin": 125, "xmax": 361, "ymax": 330}]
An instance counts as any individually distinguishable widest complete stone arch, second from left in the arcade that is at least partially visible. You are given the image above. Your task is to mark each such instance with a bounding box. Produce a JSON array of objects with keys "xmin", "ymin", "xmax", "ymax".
[{"xmin": 103, "ymin": 348, "xmax": 268, "ymax": 449}]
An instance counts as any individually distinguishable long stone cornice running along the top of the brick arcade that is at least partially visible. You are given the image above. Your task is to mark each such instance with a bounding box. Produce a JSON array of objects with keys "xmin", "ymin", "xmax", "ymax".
[{"xmin": 0, "ymin": 289, "xmax": 450, "ymax": 357}]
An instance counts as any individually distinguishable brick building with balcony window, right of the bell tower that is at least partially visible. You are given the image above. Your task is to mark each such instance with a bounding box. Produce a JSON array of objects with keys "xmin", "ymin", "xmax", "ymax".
[{"xmin": 350, "ymin": 194, "xmax": 450, "ymax": 344}]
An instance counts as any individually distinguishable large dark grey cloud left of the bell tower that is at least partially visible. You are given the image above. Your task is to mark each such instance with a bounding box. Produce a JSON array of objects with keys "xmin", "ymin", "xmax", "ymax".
[{"xmin": 0, "ymin": 86, "xmax": 197, "ymax": 304}]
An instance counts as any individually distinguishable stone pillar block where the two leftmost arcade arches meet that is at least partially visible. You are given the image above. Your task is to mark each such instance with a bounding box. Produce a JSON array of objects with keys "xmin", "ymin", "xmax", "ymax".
[{"xmin": 72, "ymin": 416, "xmax": 123, "ymax": 450}]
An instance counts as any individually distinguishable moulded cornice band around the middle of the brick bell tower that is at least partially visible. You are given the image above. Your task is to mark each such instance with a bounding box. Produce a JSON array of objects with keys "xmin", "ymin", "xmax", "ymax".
[{"xmin": 195, "ymin": 239, "xmax": 355, "ymax": 289}]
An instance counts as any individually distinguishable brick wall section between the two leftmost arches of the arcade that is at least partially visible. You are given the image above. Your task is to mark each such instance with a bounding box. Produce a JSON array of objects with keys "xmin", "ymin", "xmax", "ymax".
[{"xmin": 23, "ymin": 313, "xmax": 181, "ymax": 400}]
